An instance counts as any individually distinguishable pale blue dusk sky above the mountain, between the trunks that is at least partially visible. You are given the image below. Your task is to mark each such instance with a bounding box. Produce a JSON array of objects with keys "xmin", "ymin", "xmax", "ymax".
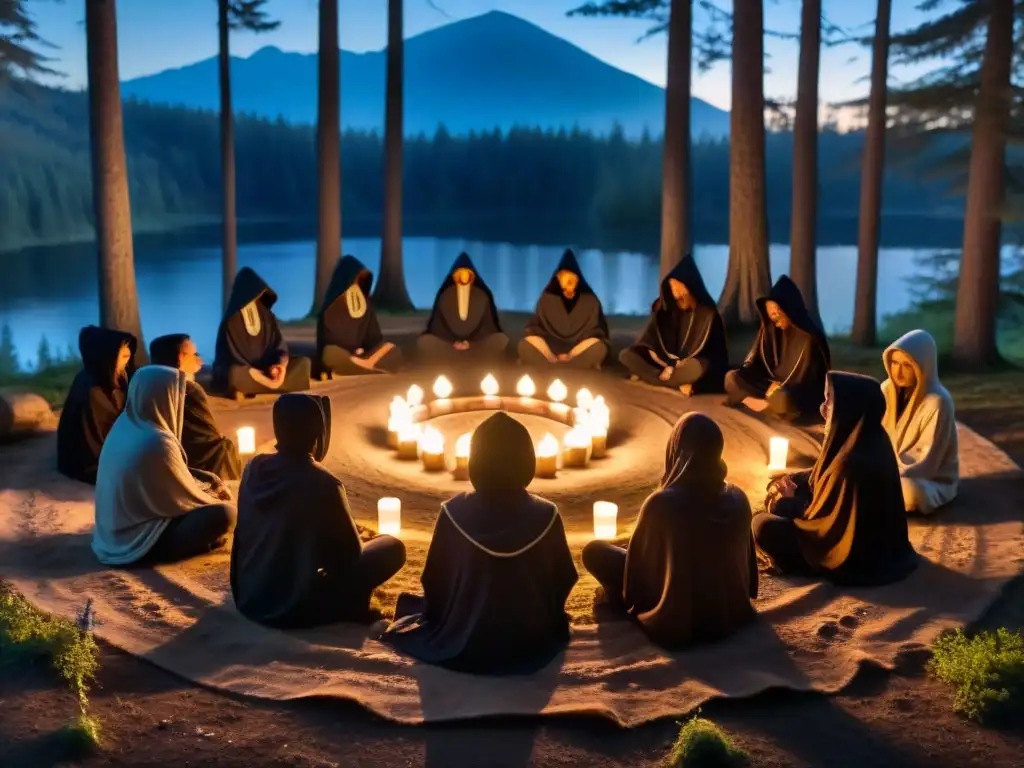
[{"xmin": 29, "ymin": 0, "xmax": 937, "ymax": 109}]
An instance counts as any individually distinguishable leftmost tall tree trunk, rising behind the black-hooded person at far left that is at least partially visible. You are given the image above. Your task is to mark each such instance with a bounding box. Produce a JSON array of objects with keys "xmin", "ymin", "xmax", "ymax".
[{"xmin": 85, "ymin": 0, "xmax": 146, "ymax": 365}]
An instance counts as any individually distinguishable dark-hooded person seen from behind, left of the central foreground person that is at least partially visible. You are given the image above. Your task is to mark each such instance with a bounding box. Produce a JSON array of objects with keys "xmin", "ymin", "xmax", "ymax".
[{"xmin": 230, "ymin": 394, "xmax": 406, "ymax": 629}]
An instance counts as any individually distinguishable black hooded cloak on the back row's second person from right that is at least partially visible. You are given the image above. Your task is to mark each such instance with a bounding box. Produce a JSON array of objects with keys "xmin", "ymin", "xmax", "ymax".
[{"xmin": 633, "ymin": 255, "xmax": 729, "ymax": 394}]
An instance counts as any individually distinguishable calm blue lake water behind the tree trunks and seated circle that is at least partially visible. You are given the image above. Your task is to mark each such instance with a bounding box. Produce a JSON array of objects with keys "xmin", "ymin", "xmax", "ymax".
[{"xmin": 0, "ymin": 230, "xmax": 958, "ymax": 365}]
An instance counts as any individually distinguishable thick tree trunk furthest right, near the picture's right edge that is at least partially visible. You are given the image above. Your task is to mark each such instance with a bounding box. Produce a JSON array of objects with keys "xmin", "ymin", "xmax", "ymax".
[{"xmin": 953, "ymin": 0, "xmax": 1014, "ymax": 369}]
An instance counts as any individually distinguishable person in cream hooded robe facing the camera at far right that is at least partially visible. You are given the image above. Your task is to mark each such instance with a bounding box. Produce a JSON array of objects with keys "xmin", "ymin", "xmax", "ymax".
[{"xmin": 882, "ymin": 331, "xmax": 959, "ymax": 515}]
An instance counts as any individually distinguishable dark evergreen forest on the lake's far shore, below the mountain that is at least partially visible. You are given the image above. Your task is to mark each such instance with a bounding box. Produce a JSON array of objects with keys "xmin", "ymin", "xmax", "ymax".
[{"xmin": 0, "ymin": 81, "xmax": 963, "ymax": 248}]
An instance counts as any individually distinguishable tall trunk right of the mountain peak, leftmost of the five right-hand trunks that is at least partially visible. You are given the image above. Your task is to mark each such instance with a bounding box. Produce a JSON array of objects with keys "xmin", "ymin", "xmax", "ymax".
[{"xmin": 662, "ymin": 0, "xmax": 693, "ymax": 278}]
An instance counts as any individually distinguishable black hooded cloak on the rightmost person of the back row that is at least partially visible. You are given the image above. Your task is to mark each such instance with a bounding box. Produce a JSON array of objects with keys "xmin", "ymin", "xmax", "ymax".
[{"xmin": 736, "ymin": 274, "xmax": 831, "ymax": 415}]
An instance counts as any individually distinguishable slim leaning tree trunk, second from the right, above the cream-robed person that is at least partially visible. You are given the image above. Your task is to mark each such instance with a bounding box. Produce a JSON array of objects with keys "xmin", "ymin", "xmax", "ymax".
[{"xmin": 851, "ymin": 0, "xmax": 893, "ymax": 347}]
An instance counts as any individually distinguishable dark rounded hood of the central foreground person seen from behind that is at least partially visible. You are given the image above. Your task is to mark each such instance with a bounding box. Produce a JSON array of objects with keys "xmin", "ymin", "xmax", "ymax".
[{"xmin": 469, "ymin": 411, "xmax": 537, "ymax": 492}]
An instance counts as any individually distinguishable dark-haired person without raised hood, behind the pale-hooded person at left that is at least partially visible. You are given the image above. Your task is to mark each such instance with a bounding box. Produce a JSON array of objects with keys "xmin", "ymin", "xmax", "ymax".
[{"xmin": 150, "ymin": 334, "xmax": 242, "ymax": 480}]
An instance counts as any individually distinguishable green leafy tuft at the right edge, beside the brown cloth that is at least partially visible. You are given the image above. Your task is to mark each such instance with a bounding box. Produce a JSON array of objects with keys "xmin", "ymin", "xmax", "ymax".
[{"xmin": 928, "ymin": 628, "xmax": 1024, "ymax": 725}]
